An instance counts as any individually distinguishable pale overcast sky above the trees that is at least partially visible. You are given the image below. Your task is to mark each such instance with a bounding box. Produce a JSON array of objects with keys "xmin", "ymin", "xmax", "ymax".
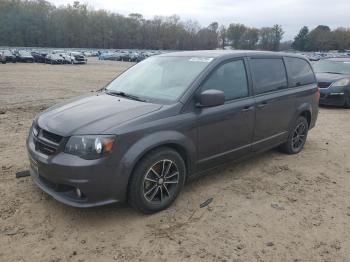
[{"xmin": 50, "ymin": 0, "xmax": 350, "ymax": 40}]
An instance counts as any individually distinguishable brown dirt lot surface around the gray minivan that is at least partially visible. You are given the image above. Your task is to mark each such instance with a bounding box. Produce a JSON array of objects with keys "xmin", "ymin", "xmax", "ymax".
[{"xmin": 0, "ymin": 59, "xmax": 350, "ymax": 261}]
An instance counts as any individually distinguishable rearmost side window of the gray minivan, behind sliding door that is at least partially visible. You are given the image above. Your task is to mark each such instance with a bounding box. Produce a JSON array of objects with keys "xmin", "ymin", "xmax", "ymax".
[{"xmin": 285, "ymin": 57, "xmax": 316, "ymax": 87}]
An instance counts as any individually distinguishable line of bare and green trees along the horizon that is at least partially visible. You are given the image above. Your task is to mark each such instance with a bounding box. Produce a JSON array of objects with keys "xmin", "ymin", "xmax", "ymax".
[{"xmin": 0, "ymin": 0, "xmax": 350, "ymax": 51}]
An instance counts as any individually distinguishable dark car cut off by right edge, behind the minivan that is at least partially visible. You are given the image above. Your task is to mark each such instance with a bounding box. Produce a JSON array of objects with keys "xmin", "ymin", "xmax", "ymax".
[{"xmin": 313, "ymin": 57, "xmax": 350, "ymax": 108}]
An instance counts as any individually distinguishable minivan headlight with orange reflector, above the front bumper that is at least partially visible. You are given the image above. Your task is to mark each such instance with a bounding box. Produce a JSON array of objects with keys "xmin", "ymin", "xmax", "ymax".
[{"xmin": 64, "ymin": 135, "xmax": 116, "ymax": 160}]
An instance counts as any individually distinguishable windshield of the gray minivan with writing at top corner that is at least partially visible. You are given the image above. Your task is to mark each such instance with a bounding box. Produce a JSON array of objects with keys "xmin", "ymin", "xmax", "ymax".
[{"xmin": 106, "ymin": 56, "xmax": 212, "ymax": 103}]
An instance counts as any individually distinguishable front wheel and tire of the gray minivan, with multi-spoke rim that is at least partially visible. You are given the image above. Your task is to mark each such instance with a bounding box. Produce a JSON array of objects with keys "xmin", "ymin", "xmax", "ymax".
[{"xmin": 128, "ymin": 147, "xmax": 186, "ymax": 214}]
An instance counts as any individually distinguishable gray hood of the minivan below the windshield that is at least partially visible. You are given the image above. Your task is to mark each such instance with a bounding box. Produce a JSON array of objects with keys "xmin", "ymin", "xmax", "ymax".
[{"xmin": 37, "ymin": 93, "xmax": 161, "ymax": 137}]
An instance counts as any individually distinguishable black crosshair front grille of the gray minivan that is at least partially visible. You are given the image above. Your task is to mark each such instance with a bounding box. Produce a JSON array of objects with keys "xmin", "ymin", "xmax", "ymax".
[{"xmin": 33, "ymin": 126, "xmax": 63, "ymax": 156}]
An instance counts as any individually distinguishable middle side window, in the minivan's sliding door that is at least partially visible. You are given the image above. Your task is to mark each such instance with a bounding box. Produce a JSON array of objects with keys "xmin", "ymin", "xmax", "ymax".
[{"xmin": 250, "ymin": 58, "xmax": 287, "ymax": 94}]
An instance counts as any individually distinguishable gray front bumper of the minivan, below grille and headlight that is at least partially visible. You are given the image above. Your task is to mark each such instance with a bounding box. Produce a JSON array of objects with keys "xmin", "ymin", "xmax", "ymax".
[{"xmin": 27, "ymin": 132, "xmax": 127, "ymax": 208}]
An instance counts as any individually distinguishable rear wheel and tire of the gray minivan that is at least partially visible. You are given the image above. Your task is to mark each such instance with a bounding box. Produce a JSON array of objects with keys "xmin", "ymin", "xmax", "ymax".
[{"xmin": 281, "ymin": 116, "xmax": 309, "ymax": 155}]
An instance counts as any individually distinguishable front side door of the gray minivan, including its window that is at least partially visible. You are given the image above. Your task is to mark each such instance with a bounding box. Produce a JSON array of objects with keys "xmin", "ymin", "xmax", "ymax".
[{"xmin": 197, "ymin": 58, "xmax": 255, "ymax": 170}]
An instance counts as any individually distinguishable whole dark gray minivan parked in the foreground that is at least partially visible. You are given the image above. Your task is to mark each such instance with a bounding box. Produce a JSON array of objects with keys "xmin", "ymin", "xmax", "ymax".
[{"xmin": 27, "ymin": 51, "xmax": 319, "ymax": 213}]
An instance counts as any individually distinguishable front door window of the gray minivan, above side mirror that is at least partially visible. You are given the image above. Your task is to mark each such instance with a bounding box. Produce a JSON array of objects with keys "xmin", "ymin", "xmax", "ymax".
[{"xmin": 201, "ymin": 60, "xmax": 248, "ymax": 101}]
